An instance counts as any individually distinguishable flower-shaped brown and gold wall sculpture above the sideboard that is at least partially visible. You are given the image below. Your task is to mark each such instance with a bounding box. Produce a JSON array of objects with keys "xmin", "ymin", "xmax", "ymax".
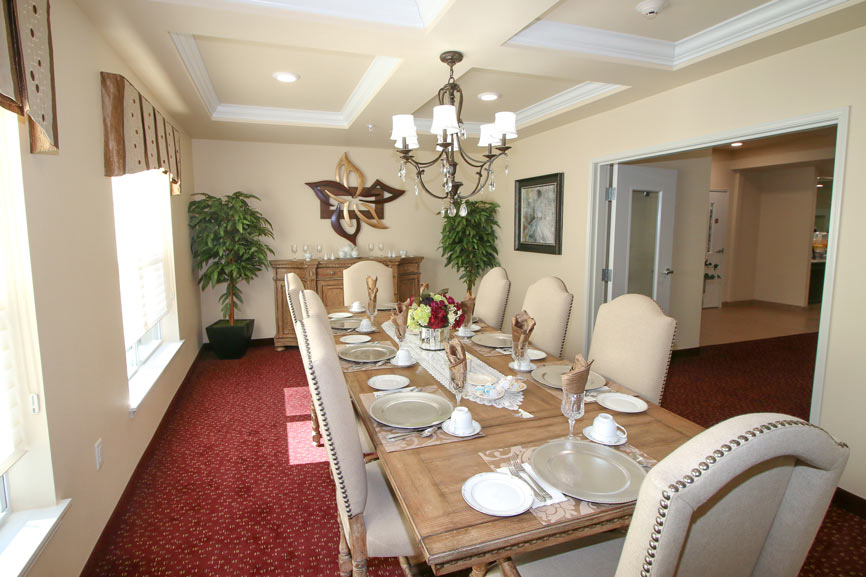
[{"xmin": 306, "ymin": 152, "xmax": 405, "ymax": 245}]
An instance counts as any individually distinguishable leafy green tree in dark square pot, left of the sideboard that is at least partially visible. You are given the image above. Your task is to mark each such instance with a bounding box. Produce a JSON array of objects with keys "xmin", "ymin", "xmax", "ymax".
[{"xmin": 188, "ymin": 191, "xmax": 274, "ymax": 359}]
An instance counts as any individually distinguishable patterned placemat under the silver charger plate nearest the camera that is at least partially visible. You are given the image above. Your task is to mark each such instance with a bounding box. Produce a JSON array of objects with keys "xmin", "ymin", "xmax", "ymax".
[{"xmin": 478, "ymin": 435, "xmax": 657, "ymax": 525}]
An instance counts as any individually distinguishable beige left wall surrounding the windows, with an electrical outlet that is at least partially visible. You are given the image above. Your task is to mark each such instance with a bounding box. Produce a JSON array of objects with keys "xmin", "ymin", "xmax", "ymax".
[{"xmin": 20, "ymin": 0, "xmax": 200, "ymax": 577}]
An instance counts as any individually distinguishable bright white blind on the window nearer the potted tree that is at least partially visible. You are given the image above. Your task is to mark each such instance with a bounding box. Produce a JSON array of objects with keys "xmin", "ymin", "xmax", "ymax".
[{"xmin": 111, "ymin": 170, "xmax": 174, "ymax": 347}]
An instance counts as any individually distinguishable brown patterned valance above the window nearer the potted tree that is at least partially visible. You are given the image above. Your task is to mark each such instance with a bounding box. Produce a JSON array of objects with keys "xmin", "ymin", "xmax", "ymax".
[{"xmin": 102, "ymin": 72, "xmax": 181, "ymax": 194}]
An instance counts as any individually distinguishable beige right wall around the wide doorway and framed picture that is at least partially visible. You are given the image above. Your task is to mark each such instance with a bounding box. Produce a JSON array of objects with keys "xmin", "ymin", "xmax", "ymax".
[{"xmin": 482, "ymin": 28, "xmax": 866, "ymax": 497}]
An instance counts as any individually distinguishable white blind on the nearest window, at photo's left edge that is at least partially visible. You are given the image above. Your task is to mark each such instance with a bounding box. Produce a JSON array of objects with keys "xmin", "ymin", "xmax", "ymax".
[{"xmin": 0, "ymin": 110, "xmax": 33, "ymax": 474}]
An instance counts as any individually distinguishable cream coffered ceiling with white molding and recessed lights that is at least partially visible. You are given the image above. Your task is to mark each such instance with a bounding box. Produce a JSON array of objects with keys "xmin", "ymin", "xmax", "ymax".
[{"xmin": 76, "ymin": 0, "xmax": 866, "ymax": 147}]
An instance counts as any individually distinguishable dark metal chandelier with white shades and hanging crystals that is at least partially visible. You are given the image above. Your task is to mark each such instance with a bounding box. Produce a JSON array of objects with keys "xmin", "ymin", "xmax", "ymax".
[{"xmin": 391, "ymin": 50, "xmax": 517, "ymax": 216}]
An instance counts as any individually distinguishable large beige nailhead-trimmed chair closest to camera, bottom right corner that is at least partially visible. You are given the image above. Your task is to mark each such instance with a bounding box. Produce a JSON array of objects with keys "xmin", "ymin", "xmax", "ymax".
[{"xmin": 489, "ymin": 413, "xmax": 848, "ymax": 577}]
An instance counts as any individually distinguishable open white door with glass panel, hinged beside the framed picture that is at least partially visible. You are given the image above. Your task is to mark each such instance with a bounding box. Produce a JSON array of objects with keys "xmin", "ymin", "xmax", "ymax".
[{"xmin": 608, "ymin": 164, "xmax": 677, "ymax": 313}]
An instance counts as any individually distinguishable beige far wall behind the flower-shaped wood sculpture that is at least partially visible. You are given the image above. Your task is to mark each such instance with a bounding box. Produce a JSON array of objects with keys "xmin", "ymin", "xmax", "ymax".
[{"xmin": 187, "ymin": 138, "xmax": 465, "ymax": 338}]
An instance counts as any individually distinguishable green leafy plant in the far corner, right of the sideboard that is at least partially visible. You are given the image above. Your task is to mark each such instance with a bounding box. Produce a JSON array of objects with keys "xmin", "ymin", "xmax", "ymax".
[{"xmin": 439, "ymin": 200, "xmax": 499, "ymax": 292}]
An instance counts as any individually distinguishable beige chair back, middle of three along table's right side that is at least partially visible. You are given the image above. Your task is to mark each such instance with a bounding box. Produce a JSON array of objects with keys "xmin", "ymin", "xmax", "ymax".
[{"xmin": 523, "ymin": 276, "xmax": 574, "ymax": 357}]
